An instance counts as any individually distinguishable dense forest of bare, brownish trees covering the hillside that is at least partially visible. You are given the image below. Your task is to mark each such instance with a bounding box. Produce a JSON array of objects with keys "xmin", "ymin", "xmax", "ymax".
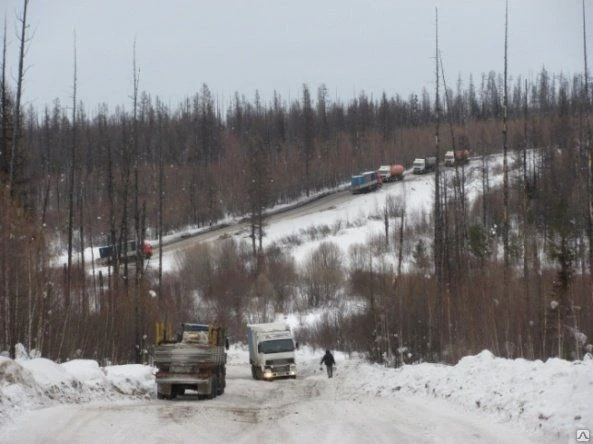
[{"xmin": 0, "ymin": 2, "xmax": 593, "ymax": 362}]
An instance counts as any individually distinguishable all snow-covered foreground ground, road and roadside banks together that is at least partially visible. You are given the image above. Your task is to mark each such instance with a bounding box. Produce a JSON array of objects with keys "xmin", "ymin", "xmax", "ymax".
[{"xmin": 0, "ymin": 344, "xmax": 593, "ymax": 444}]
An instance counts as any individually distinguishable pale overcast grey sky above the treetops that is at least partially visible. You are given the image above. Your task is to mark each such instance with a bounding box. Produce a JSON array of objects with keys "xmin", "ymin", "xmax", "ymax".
[{"xmin": 0, "ymin": 0, "xmax": 593, "ymax": 113}]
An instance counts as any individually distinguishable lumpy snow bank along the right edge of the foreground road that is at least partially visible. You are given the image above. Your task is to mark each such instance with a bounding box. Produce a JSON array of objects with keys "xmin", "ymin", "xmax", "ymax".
[{"xmin": 330, "ymin": 351, "xmax": 593, "ymax": 439}]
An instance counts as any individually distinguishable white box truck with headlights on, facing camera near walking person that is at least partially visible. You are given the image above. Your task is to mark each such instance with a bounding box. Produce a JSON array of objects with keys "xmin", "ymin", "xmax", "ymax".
[{"xmin": 247, "ymin": 322, "xmax": 298, "ymax": 380}]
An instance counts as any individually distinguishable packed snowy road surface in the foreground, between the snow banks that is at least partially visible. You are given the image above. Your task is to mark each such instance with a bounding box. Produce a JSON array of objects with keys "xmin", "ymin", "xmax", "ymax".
[{"xmin": 0, "ymin": 361, "xmax": 536, "ymax": 444}]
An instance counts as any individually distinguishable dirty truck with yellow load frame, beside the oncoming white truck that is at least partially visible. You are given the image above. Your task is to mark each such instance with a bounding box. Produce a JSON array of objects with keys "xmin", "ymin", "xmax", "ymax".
[{"xmin": 153, "ymin": 322, "xmax": 229, "ymax": 399}]
